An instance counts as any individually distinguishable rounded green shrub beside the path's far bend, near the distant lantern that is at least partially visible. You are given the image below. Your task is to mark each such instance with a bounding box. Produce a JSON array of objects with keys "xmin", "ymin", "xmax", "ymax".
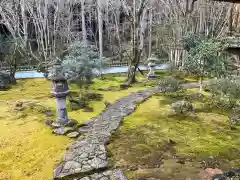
[{"xmin": 158, "ymin": 76, "xmax": 181, "ymax": 92}]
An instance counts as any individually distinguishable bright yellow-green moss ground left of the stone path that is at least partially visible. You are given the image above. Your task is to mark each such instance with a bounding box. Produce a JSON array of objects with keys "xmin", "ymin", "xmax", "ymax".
[{"xmin": 0, "ymin": 73, "xmax": 144, "ymax": 180}]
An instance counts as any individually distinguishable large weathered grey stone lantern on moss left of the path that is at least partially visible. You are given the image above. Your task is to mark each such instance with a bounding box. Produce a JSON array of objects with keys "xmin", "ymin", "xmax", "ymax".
[{"xmin": 50, "ymin": 59, "xmax": 70, "ymax": 127}]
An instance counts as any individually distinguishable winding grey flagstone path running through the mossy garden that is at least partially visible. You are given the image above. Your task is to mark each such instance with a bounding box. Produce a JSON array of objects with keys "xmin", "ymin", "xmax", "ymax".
[{"xmin": 54, "ymin": 83, "xmax": 208, "ymax": 180}]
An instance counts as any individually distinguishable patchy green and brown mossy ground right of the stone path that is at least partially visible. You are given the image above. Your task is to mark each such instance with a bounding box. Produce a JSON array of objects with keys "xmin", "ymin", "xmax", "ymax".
[{"xmin": 108, "ymin": 90, "xmax": 240, "ymax": 180}]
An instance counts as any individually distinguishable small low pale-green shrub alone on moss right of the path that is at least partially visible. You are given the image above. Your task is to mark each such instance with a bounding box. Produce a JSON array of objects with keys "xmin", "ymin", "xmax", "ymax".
[{"xmin": 171, "ymin": 100, "xmax": 195, "ymax": 115}]
